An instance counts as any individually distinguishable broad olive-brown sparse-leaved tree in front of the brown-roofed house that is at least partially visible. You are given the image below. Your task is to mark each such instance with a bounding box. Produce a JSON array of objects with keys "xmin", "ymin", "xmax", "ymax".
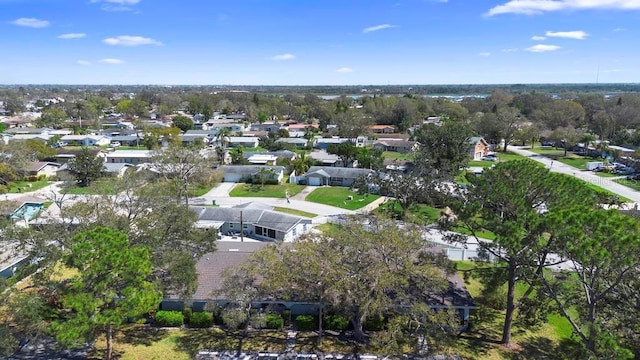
[{"xmin": 254, "ymin": 218, "xmax": 450, "ymax": 341}]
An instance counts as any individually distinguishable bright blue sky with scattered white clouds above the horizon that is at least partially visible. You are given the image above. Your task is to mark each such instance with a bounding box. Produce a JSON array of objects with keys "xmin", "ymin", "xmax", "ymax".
[{"xmin": 0, "ymin": 0, "xmax": 640, "ymax": 85}]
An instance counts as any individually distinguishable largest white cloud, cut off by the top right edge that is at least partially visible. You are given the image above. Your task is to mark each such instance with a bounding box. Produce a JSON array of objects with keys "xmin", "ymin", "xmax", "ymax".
[{"xmin": 485, "ymin": 0, "xmax": 640, "ymax": 16}]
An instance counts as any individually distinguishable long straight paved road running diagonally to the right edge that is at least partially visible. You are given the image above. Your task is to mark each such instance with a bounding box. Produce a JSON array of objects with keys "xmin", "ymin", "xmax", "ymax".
[{"xmin": 507, "ymin": 146, "xmax": 640, "ymax": 208}]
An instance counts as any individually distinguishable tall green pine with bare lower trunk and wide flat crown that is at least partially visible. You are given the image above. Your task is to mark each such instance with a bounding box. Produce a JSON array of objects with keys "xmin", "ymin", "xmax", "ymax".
[{"xmin": 442, "ymin": 160, "xmax": 596, "ymax": 346}]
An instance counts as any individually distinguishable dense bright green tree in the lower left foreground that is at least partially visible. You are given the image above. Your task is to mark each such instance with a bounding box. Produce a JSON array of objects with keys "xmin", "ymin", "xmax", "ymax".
[{"xmin": 52, "ymin": 227, "xmax": 161, "ymax": 360}]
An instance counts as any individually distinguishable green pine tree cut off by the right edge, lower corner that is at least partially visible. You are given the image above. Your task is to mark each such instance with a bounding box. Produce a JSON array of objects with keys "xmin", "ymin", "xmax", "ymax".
[{"xmin": 539, "ymin": 207, "xmax": 640, "ymax": 359}]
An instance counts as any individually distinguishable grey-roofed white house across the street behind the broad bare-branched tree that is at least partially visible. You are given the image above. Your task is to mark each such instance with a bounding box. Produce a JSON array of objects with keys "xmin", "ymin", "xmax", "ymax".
[{"xmin": 191, "ymin": 203, "xmax": 311, "ymax": 242}]
